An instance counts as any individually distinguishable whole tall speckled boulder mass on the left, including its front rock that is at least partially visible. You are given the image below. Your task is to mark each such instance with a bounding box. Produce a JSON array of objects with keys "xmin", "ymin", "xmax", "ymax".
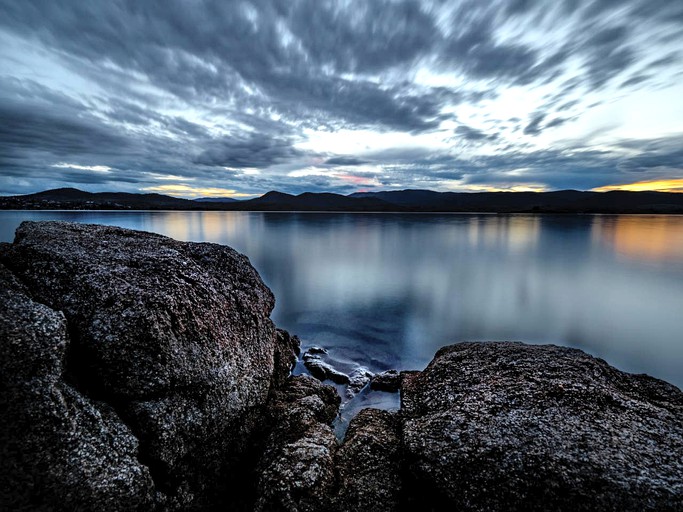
[{"xmin": 0, "ymin": 222, "xmax": 296, "ymax": 510}]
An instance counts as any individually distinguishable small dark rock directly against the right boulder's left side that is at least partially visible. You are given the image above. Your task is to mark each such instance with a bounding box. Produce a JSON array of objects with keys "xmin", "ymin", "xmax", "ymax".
[{"xmin": 335, "ymin": 409, "xmax": 402, "ymax": 512}]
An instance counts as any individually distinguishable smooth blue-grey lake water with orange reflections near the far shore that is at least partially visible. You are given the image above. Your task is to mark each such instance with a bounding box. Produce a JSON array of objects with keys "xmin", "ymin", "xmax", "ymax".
[{"xmin": 0, "ymin": 211, "xmax": 683, "ymax": 390}]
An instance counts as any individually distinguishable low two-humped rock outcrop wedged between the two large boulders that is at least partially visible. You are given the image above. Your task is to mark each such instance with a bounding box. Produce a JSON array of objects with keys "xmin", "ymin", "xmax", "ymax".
[{"xmin": 256, "ymin": 376, "xmax": 401, "ymax": 512}]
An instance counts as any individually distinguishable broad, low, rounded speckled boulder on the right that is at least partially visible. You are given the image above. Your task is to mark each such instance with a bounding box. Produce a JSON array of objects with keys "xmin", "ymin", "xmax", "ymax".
[{"xmin": 401, "ymin": 343, "xmax": 683, "ymax": 511}]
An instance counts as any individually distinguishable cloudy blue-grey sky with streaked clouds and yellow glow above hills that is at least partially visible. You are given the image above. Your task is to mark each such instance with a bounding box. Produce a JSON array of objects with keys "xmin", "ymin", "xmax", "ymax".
[{"xmin": 0, "ymin": 0, "xmax": 683, "ymax": 198}]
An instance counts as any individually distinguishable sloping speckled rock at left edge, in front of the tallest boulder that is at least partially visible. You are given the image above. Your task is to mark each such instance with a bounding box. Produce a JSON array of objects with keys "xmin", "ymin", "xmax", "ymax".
[{"xmin": 0, "ymin": 265, "xmax": 155, "ymax": 511}]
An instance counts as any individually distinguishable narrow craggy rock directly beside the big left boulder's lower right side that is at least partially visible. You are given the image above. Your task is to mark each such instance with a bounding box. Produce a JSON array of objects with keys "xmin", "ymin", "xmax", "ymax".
[{"xmin": 255, "ymin": 376, "xmax": 340, "ymax": 511}]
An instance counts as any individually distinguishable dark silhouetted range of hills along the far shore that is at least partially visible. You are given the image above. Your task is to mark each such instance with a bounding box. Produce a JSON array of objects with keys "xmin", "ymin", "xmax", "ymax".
[{"xmin": 0, "ymin": 188, "xmax": 683, "ymax": 214}]
